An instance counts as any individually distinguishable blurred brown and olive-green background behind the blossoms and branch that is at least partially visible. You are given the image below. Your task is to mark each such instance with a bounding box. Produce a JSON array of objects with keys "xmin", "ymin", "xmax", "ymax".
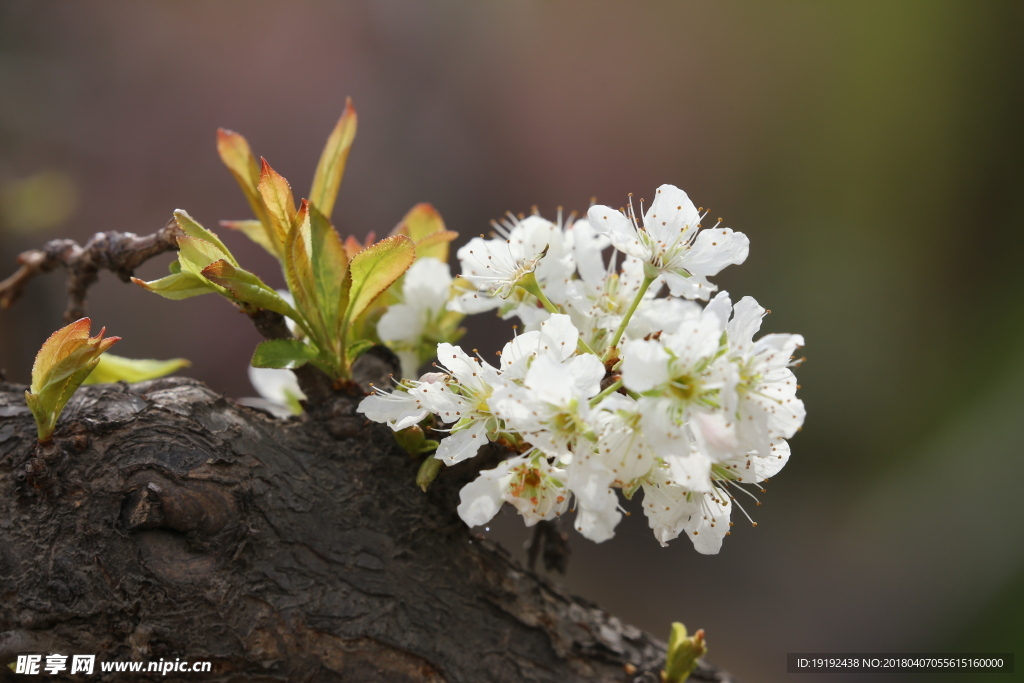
[{"xmin": 0, "ymin": 0, "xmax": 1024, "ymax": 682}]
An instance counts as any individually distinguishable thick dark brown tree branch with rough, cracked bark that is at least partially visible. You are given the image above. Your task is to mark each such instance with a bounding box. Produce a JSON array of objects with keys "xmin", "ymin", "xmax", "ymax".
[{"xmin": 0, "ymin": 379, "xmax": 733, "ymax": 683}]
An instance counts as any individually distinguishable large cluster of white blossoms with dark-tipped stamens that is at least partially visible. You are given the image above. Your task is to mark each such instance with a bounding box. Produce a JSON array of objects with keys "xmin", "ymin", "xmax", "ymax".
[{"xmin": 359, "ymin": 185, "xmax": 804, "ymax": 553}]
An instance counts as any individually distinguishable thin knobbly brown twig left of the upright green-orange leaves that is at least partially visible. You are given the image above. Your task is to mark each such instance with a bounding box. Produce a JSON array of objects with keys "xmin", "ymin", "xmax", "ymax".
[{"xmin": 0, "ymin": 220, "xmax": 182, "ymax": 323}]
